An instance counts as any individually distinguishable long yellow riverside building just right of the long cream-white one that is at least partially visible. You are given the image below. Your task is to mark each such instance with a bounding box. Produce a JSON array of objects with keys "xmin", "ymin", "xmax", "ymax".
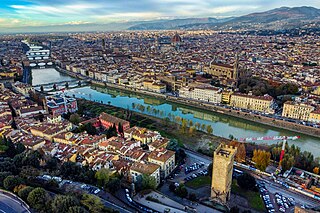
[{"xmin": 230, "ymin": 93, "xmax": 275, "ymax": 114}]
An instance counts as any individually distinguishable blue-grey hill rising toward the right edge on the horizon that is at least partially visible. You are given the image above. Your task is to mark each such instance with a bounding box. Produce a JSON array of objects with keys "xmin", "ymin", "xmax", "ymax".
[{"xmin": 129, "ymin": 7, "xmax": 320, "ymax": 30}]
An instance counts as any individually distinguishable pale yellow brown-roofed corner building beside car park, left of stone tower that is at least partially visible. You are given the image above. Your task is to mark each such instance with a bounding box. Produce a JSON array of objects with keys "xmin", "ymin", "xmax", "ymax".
[{"xmin": 148, "ymin": 149, "xmax": 175, "ymax": 178}]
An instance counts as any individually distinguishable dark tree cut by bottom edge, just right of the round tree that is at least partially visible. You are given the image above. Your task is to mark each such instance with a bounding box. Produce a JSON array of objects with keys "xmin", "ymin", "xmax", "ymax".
[{"xmin": 51, "ymin": 195, "xmax": 80, "ymax": 212}]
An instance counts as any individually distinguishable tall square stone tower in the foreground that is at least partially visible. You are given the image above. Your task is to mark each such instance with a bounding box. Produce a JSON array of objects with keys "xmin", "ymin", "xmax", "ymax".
[{"xmin": 211, "ymin": 144, "xmax": 237, "ymax": 203}]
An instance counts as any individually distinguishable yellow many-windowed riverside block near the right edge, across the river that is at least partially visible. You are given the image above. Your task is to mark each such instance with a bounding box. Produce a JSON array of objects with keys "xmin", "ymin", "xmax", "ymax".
[{"xmin": 282, "ymin": 101, "xmax": 314, "ymax": 121}]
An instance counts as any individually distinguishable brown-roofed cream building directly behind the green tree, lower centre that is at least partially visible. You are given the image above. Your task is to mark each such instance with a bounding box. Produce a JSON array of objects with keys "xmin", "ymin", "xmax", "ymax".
[{"xmin": 130, "ymin": 162, "xmax": 160, "ymax": 186}]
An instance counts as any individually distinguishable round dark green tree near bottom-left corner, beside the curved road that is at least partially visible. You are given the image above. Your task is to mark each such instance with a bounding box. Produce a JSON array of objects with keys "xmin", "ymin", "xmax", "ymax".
[{"xmin": 27, "ymin": 187, "xmax": 51, "ymax": 211}]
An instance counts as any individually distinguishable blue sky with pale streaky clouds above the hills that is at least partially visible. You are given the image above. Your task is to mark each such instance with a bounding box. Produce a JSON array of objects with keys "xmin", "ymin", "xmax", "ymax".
[{"xmin": 0, "ymin": 0, "xmax": 320, "ymax": 29}]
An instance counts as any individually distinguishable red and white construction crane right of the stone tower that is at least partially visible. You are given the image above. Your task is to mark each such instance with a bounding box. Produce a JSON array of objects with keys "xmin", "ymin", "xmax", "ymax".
[{"xmin": 239, "ymin": 136, "xmax": 300, "ymax": 172}]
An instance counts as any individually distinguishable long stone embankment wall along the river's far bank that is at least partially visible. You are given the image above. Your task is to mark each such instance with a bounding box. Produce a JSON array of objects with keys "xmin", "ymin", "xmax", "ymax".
[{"xmin": 57, "ymin": 68, "xmax": 320, "ymax": 139}]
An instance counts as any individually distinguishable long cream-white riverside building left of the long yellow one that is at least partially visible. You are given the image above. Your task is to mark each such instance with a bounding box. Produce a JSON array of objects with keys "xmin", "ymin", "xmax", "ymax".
[{"xmin": 179, "ymin": 86, "xmax": 222, "ymax": 103}]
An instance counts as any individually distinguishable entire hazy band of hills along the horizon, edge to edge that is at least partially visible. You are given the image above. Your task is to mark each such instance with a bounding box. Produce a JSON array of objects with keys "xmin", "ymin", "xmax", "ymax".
[{"xmin": 0, "ymin": 6, "xmax": 320, "ymax": 34}]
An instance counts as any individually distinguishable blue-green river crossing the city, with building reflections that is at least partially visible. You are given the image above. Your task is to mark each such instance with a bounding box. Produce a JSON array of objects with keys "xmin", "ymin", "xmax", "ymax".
[{"xmin": 32, "ymin": 68, "xmax": 320, "ymax": 157}]
